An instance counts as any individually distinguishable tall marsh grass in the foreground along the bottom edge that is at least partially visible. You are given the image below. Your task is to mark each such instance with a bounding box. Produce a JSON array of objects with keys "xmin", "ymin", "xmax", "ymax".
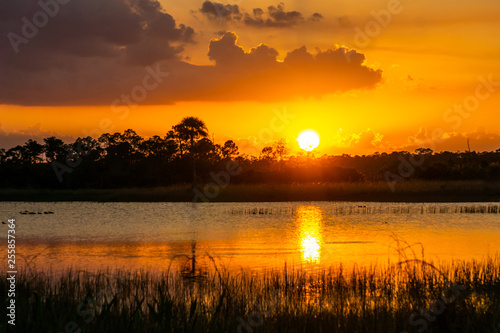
[{"xmin": 0, "ymin": 254, "xmax": 500, "ymax": 333}]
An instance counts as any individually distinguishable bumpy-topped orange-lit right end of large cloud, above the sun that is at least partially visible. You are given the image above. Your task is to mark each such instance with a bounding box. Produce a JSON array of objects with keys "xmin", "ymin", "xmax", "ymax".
[{"xmin": 158, "ymin": 32, "xmax": 382, "ymax": 101}]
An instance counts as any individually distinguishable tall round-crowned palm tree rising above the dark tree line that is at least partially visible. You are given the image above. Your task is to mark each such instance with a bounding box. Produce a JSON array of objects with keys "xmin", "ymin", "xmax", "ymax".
[{"xmin": 174, "ymin": 117, "xmax": 208, "ymax": 188}]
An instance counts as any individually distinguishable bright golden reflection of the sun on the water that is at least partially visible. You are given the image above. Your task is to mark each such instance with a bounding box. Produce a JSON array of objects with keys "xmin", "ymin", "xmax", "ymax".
[{"xmin": 297, "ymin": 206, "xmax": 323, "ymax": 264}]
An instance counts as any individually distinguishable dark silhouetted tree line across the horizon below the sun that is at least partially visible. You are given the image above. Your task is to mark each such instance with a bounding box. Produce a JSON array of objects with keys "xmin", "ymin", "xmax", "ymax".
[{"xmin": 0, "ymin": 117, "xmax": 500, "ymax": 189}]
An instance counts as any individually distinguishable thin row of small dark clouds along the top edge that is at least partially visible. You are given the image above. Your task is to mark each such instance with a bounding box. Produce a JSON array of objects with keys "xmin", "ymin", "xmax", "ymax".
[{"xmin": 199, "ymin": 1, "xmax": 323, "ymax": 28}]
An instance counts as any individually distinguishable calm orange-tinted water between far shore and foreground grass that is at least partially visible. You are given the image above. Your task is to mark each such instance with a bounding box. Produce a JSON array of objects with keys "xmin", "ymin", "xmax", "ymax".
[{"xmin": 0, "ymin": 202, "xmax": 500, "ymax": 271}]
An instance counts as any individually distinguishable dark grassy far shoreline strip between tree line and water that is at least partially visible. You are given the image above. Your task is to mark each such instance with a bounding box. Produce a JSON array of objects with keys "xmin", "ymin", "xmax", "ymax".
[{"xmin": 0, "ymin": 180, "xmax": 500, "ymax": 203}]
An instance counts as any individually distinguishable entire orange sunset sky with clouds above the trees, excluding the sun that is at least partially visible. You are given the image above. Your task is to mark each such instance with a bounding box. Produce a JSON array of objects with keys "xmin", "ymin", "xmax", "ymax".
[{"xmin": 0, "ymin": 0, "xmax": 500, "ymax": 155}]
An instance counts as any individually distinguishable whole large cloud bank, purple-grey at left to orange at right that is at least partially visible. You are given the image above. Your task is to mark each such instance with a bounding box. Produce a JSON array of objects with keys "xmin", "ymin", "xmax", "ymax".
[{"xmin": 0, "ymin": 0, "xmax": 382, "ymax": 106}]
